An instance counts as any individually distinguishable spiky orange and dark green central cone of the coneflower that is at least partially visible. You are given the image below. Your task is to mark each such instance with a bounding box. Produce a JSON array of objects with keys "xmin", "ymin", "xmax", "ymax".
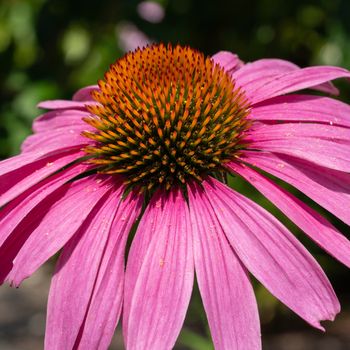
[{"xmin": 84, "ymin": 44, "xmax": 249, "ymax": 190}]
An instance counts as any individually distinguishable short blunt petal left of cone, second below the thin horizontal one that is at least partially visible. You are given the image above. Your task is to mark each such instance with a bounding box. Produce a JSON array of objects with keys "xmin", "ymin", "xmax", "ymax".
[{"xmin": 21, "ymin": 124, "xmax": 91, "ymax": 153}]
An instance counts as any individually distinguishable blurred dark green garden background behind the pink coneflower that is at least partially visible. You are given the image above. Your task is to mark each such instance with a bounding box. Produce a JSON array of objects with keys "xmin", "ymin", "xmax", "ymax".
[{"xmin": 0, "ymin": 0, "xmax": 350, "ymax": 350}]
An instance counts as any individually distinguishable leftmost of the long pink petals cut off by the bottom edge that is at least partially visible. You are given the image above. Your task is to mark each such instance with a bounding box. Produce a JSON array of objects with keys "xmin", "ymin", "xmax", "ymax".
[{"xmin": 45, "ymin": 187, "xmax": 122, "ymax": 350}]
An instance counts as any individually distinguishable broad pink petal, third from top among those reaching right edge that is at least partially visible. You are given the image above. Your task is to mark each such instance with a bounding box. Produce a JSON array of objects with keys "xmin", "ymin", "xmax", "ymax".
[{"xmin": 247, "ymin": 123, "xmax": 350, "ymax": 172}]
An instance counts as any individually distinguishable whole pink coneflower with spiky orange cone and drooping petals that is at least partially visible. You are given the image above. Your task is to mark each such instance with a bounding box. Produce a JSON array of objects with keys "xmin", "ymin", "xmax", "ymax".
[{"xmin": 0, "ymin": 45, "xmax": 350, "ymax": 350}]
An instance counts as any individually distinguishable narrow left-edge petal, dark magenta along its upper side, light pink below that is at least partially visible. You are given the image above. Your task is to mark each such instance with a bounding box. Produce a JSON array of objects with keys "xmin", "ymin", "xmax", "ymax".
[{"xmin": 0, "ymin": 152, "xmax": 85, "ymax": 207}]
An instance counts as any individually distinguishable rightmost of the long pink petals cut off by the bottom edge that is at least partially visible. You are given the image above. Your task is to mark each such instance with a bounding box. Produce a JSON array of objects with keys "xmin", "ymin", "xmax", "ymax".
[{"xmin": 189, "ymin": 184, "xmax": 261, "ymax": 350}]
